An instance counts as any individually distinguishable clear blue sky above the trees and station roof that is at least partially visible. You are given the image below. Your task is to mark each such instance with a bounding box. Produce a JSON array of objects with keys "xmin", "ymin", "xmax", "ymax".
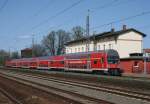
[{"xmin": 0, "ymin": 0, "xmax": 150, "ymax": 51}]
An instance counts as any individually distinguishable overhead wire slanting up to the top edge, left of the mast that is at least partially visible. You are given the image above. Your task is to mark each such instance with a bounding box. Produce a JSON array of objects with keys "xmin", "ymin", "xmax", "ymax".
[{"xmin": 32, "ymin": 0, "xmax": 83, "ymax": 30}]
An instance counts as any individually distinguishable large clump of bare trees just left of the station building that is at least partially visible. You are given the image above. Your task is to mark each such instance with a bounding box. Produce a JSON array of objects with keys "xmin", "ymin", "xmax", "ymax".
[{"xmin": 42, "ymin": 30, "xmax": 70, "ymax": 55}]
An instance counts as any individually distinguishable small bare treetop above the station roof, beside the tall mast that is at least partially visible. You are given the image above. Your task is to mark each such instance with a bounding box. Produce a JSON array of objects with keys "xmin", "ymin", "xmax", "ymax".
[{"xmin": 72, "ymin": 26, "xmax": 85, "ymax": 40}]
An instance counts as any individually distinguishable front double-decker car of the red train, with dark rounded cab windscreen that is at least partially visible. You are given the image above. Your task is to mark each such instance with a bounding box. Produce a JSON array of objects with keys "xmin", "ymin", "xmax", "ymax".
[{"xmin": 65, "ymin": 49, "xmax": 121, "ymax": 75}]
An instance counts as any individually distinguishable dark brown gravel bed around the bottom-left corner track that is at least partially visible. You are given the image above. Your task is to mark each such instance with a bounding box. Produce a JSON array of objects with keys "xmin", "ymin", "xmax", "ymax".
[{"xmin": 0, "ymin": 77, "xmax": 78, "ymax": 104}]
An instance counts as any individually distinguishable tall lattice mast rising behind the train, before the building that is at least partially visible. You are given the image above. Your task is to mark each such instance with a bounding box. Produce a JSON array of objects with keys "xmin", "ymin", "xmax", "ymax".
[{"xmin": 86, "ymin": 10, "xmax": 90, "ymax": 52}]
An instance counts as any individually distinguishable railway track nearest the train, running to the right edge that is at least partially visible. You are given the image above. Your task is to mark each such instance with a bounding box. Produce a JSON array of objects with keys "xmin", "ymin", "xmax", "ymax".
[{"xmin": 4, "ymin": 69, "xmax": 150, "ymax": 101}]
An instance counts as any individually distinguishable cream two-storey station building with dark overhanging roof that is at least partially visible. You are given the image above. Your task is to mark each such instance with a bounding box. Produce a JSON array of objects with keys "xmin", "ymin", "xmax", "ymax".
[{"xmin": 66, "ymin": 27, "xmax": 146, "ymax": 58}]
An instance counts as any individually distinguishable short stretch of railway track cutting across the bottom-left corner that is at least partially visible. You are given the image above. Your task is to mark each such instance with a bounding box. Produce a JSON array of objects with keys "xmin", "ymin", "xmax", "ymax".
[{"xmin": 0, "ymin": 88, "xmax": 23, "ymax": 104}]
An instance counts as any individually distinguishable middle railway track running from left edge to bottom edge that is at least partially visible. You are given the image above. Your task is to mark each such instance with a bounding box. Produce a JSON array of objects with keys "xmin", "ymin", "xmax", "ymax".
[{"xmin": 0, "ymin": 69, "xmax": 112, "ymax": 104}]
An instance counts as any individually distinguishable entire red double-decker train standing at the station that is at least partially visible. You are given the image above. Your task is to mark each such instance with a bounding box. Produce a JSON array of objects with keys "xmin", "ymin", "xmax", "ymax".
[{"xmin": 6, "ymin": 49, "xmax": 122, "ymax": 75}]
